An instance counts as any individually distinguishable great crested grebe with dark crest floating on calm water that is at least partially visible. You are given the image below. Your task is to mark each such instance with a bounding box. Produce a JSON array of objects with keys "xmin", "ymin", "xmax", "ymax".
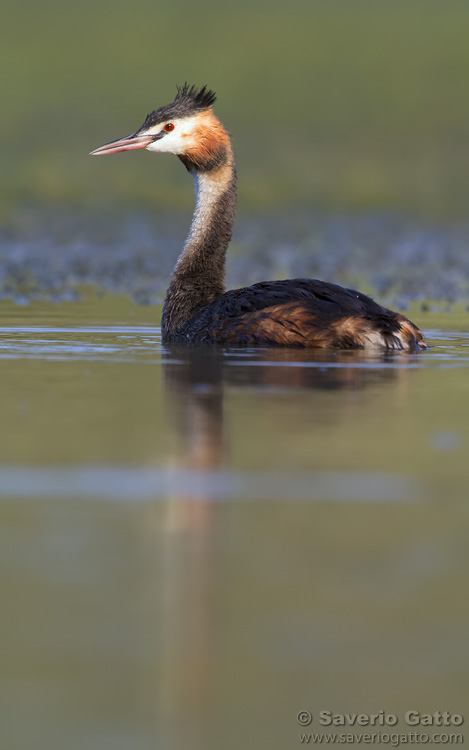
[{"xmin": 91, "ymin": 83, "xmax": 427, "ymax": 351}]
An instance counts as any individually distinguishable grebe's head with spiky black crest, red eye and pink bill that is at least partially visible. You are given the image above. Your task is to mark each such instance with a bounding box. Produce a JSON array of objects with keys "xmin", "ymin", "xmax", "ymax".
[{"xmin": 91, "ymin": 83, "xmax": 230, "ymax": 172}]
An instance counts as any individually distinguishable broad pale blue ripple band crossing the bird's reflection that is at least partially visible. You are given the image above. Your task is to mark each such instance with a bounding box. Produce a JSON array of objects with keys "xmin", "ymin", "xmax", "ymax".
[{"xmin": 0, "ymin": 466, "xmax": 423, "ymax": 502}]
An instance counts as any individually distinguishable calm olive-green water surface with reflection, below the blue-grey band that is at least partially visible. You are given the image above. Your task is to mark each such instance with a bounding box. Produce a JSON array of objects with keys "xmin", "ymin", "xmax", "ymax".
[{"xmin": 0, "ymin": 298, "xmax": 469, "ymax": 750}]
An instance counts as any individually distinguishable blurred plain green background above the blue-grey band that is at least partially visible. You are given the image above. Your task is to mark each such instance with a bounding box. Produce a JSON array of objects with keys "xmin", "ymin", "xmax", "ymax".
[{"xmin": 0, "ymin": 0, "xmax": 469, "ymax": 222}]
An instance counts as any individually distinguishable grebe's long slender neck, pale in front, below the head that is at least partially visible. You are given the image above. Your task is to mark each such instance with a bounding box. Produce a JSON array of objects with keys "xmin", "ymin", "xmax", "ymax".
[{"xmin": 162, "ymin": 148, "xmax": 236, "ymax": 340}]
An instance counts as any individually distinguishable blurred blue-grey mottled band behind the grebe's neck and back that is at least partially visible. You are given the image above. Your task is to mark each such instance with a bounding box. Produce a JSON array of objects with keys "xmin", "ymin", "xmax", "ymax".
[{"xmin": 0, "ymin": 210, "xmax": 469, "ymax": 309}]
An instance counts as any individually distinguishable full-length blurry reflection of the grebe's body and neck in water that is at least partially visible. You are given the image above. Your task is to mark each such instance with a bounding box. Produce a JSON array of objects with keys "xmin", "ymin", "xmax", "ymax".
[{"xmin": 147, "ymin": 345, "xmax": 412, "ymax": 748}]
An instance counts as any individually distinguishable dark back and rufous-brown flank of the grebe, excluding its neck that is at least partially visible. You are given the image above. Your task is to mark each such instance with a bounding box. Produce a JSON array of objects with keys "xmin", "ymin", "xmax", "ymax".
[{"xmin": 183, "ymin": 279, "xmax": 425, "ymax": 349}]
